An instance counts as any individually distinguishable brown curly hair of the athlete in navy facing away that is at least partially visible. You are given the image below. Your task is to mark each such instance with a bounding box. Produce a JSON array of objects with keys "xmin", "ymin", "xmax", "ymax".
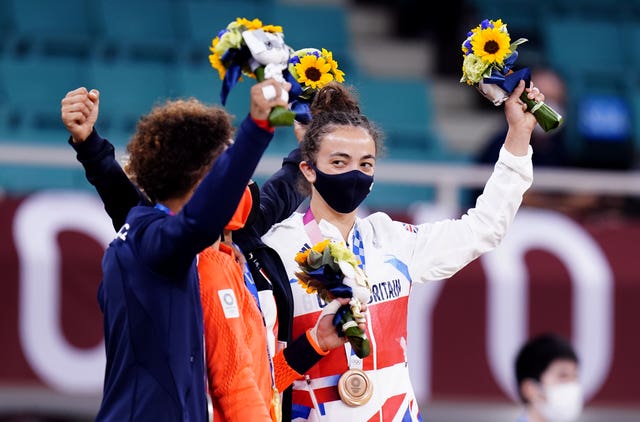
[{"xmin": 125, "ymin": 98, "xmax": 234, "ymax": 202}]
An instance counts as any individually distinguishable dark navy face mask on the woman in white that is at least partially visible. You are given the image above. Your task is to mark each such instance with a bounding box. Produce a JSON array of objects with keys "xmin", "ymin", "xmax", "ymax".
[{"xmin": 307, "ymin": 162, "xmax": 373, "ymax": 214}]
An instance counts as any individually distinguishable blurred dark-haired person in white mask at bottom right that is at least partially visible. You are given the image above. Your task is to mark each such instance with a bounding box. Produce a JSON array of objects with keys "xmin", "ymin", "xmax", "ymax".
[{"xmin": 514, "ymin": 333, "xmax": 583, "ymax": 422}]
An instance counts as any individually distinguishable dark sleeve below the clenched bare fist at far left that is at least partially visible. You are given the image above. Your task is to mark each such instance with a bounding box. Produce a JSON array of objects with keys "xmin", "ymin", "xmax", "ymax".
[{"xmin": 68, "ymin": 129, "xmax": 149, "ymax": 230}]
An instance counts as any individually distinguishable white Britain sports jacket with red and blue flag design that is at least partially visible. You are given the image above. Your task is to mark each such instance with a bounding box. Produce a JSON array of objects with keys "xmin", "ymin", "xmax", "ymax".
[{"xmin": 263, "ymin": 147, "xmax": 533, "ymax": 421}]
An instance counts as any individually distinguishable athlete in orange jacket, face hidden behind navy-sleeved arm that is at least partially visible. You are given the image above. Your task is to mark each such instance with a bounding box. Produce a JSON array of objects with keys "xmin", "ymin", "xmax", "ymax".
[{"xmin": 198, "ymin": 188, "xmax": 360, "ymax": 422}]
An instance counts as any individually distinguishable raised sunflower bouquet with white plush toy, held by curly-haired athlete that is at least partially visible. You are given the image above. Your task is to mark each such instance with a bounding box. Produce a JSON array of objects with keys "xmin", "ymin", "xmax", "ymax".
[{"xmin": 209, "ymin": 18, "xmax": 295, "ymax": 126}]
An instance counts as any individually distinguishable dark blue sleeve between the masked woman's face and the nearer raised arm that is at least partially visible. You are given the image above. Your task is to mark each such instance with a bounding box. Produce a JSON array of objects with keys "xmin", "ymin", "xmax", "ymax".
[{"xmin": 252, "ymin": 148, "xmax": 306, "ymax": 236}]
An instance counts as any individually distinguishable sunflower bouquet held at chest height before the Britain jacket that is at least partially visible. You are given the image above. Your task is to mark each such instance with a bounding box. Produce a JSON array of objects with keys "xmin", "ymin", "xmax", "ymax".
[{"xmin": 295, "ymin": 239, "xmax": 371, "ymax": 358}]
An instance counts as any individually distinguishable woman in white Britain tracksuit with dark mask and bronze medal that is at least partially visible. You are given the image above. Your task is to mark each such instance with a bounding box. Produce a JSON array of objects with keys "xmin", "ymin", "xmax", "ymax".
[{"xmin": 263, "ymin": 82, "xmax": 544, "ymax": 421}]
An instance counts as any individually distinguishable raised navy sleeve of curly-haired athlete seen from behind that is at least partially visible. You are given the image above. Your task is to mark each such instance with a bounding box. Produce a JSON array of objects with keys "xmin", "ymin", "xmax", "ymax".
[{"xmin": 138, "ymin": 117, "xmax": 273, "ymax": 268}]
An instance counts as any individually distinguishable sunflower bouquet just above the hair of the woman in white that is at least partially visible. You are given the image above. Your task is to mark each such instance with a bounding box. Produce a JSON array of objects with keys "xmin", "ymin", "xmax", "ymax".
[{"xmin": 287, "ymin": 48, "xmax": 344, "ymax": 124}]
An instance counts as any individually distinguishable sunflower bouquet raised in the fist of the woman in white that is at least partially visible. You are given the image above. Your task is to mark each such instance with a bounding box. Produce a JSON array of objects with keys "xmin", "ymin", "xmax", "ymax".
[{"xmin": 460, "ymin": 19, "xmax": 563, "ymax": 132}]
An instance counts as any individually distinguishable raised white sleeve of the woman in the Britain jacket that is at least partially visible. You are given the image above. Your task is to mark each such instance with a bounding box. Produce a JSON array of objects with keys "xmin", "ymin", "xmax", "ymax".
[{"xmin": 409, "ymin": 146, "xmax": 533, "ymax": 281}]
